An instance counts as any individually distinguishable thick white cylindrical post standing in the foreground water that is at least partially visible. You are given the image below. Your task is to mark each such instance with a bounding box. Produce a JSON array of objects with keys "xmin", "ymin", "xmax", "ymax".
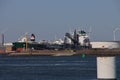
[{"xmin": 97, "ymin": 56, "xmax": 117, "ymax": 80}]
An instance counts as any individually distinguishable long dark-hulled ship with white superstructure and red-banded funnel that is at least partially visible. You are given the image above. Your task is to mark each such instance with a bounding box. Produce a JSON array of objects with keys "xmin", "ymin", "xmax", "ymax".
[{"xmin": 12, "ymin": 29, "xmax": 91, "ymax": 52}]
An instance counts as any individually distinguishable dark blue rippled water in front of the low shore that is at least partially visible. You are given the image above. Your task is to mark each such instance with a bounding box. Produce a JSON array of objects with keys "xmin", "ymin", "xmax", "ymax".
[{"xmin": 0, "ymin": 56, "xmax": 120, "ymax": 80}]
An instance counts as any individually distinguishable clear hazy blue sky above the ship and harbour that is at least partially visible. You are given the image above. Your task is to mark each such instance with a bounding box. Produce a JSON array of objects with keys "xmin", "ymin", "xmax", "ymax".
[{"xmin": 0, "ymin": 0, "xmax": 120, "ymax": 42}]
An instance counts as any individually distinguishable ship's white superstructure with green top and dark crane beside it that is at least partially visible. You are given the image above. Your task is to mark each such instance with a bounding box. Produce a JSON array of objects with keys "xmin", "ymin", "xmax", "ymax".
[{"xmin": 64, "ymin": 30, "xmax": 91, "ymax": 47}]
